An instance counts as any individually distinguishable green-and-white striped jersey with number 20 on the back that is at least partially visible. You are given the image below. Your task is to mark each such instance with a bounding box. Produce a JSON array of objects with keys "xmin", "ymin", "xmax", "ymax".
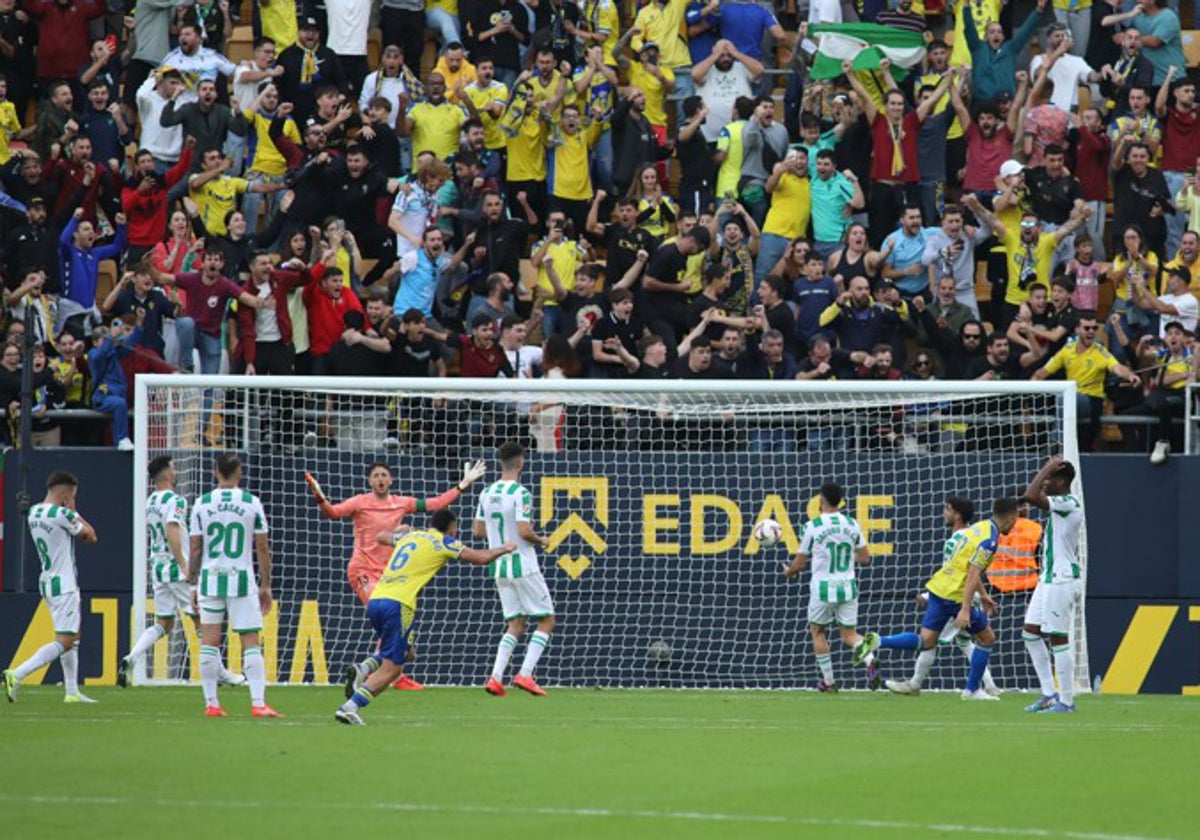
[{"xmin": 190, "ymin": 487, "xmax": 268, "ymax": 598}]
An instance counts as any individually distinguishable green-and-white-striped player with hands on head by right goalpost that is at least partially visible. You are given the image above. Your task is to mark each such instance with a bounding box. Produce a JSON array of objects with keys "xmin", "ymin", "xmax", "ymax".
[{"xmin": 1021, "ymin": 455, "xmax": 1084, "ymax": 714}]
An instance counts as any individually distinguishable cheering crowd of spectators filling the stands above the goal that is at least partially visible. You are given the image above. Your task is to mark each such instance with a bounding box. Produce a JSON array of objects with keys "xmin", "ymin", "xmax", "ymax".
[{"xmin": 0, "ymin": 0, "xmax": 1200, "ymax": 460}]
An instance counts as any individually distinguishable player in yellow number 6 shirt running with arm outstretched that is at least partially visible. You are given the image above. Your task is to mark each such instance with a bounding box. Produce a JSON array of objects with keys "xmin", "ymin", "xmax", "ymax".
[{"xmin": 334, "ymin": 508, "xmax": 517, "ymax": 726}]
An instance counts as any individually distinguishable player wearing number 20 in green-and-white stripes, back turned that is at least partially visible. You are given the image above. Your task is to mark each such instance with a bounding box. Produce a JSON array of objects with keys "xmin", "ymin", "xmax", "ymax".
[{"xmin": 187, "ymin": 454, "xmax": 283, "ymax": 718}]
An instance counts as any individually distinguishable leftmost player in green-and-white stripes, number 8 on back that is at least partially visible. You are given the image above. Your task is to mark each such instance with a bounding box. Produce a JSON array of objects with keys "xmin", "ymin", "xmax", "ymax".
[{"xmin": 4, "ymin": 473, "xmax": 96, "ymax": 703}]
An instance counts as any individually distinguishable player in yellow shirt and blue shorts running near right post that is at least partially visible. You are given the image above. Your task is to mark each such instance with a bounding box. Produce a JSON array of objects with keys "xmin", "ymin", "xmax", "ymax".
[{"xmin": 854, "ymin": 498, "xmax": 1019, "ymax": 700}]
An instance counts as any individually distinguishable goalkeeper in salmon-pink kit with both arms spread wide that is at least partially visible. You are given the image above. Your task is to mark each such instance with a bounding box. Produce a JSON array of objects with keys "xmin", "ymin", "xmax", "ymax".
[{"xmin": 304, "ymin": 461, "xmax": 487, "ymax": 690}]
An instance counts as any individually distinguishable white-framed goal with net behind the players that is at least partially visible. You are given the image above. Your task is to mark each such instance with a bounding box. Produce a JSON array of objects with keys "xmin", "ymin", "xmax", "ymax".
[{"xmin": 133, "ymin": 376, "xmax": 1088, "ymax": 690}]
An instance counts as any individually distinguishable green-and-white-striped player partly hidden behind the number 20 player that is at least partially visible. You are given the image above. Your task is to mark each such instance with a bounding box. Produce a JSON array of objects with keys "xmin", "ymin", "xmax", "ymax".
[{"xmin": 116, "ymin": 455, "xmax": 246, "ymax": 689}]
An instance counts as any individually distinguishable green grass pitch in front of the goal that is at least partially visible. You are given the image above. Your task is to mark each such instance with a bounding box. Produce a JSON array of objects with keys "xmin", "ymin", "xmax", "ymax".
[{"xmin": 0, "ymin": 686, "xmax": 1200, "ymax": 840}]
